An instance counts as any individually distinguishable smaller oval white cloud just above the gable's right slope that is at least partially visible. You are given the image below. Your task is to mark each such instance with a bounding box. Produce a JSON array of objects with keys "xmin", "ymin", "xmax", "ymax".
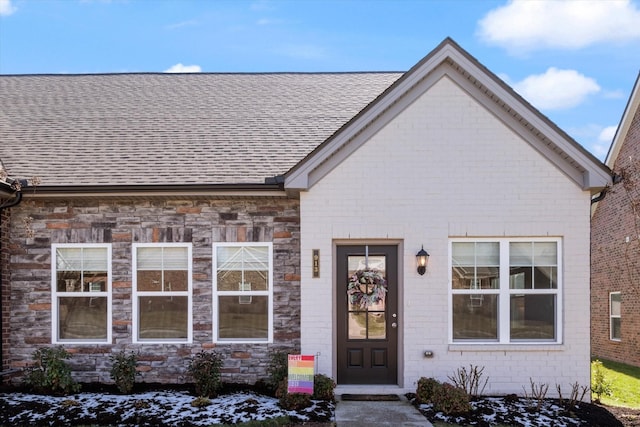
[{"xmin": 512, "ymin": 67, "xmax": 600, "ymax": 110}]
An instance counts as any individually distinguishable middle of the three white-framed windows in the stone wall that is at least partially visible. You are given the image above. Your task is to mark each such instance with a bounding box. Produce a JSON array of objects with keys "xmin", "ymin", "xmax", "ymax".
[{"xmin": 133, "ymin": 243, "xmax": 192, "ymax": 342}]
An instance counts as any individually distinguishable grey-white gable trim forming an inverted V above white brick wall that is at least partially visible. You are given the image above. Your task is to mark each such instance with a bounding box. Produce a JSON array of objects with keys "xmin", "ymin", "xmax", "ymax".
[{"xmin": 285, "ymin": 37, "xmax": 611, "ymax": 193}]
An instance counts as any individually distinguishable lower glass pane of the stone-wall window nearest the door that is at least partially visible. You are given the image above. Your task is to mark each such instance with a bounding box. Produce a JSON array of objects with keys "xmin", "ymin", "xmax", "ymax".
[{"xmin": 218, "ymin": 296, "xmax": 269, "ymax": 340}]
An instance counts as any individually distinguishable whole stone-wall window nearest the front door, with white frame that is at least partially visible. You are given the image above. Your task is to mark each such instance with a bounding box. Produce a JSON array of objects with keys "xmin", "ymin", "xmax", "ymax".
[{"xmin": 213, "ymin": 243, "xmax": 273, "ymax": 342}]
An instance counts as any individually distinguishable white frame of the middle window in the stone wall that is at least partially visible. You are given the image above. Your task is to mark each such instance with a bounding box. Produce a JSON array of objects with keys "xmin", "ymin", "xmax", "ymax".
[{"xmin": 131, "ymin": 243, "xmax": 193, "ymax": 344}]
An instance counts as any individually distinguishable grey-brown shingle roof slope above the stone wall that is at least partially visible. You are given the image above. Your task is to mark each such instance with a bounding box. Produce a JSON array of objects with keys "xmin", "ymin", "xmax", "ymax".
[{"xmin": 0, "ymin": 73, "xmax": 401, "ymax": 186}]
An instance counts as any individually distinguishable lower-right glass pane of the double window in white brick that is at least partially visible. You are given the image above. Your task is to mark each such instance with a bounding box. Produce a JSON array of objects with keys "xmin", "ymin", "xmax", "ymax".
[{"xmin": 510, "ymin": 295, "xmax": 556, "ymax": 340}]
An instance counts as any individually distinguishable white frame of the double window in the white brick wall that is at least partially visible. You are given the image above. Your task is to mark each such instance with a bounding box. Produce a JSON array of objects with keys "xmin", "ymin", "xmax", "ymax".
[{"xmin": 448, "ymin": 237, "xmax": 564, "ymax": 345}]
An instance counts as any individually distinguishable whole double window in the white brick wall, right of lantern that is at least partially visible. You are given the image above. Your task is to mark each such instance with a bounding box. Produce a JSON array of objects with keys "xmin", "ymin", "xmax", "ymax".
[{"xmin": 450, "ymin": 239, "xmax": 561, "ymax": 343}]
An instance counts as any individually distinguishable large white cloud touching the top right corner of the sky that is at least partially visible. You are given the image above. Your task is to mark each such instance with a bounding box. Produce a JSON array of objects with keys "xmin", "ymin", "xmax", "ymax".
[{"xmin": 478, "ymin": 0, "xmax": 640, "ymax": 51}]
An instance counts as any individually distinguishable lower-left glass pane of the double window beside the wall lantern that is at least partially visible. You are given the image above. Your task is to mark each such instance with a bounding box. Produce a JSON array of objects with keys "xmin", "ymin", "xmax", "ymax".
[{"xmin": 453, "ymin": 294, "xmax": 498, "ymax": 340}]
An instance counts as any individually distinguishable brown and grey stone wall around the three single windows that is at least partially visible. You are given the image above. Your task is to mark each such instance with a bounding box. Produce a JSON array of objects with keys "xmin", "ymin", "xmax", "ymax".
[{"xmin": 8, "ymin": 197, "xmax": 300, "ymax": 383}]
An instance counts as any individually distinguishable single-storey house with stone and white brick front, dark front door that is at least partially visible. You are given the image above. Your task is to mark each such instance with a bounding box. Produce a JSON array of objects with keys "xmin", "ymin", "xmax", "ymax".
[{"xmin": 0, "ymin": 39, "xmax": 611, "ymax": 394}]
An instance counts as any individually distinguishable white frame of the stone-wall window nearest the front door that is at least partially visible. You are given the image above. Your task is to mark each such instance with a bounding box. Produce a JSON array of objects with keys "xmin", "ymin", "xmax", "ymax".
[{"xmin": 212, "ymin": 242, "xmax": 274, "ymax": 344}]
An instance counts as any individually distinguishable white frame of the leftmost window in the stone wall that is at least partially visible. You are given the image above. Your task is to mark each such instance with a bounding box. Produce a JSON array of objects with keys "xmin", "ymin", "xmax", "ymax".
[{"xmin": 51, "ymin": 243, "xmax": 113, "ymax": 344}]
